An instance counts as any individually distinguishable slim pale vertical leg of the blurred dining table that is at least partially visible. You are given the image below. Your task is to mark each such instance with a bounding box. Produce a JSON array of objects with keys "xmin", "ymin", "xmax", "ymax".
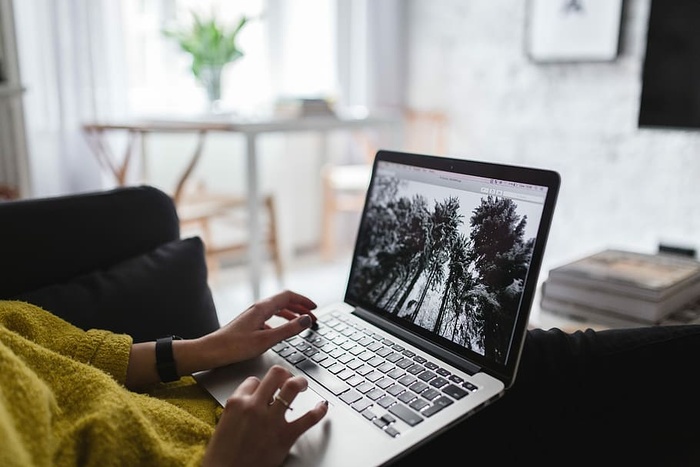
[{"xmin": 246, "ymin": 133, "xmax": 262, "ymax": 300}]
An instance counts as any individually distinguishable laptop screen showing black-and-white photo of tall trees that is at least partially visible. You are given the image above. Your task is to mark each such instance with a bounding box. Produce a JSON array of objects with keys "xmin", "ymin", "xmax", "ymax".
[{"xmin": 345, "ymin": 151, "xmax": 559, "ymax": 388}]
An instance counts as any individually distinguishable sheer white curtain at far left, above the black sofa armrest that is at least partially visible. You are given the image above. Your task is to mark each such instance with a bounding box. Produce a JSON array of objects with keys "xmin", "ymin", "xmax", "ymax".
[{"xmin": 14, "ymin": 0, "xmax": 125, "ymax": 196}]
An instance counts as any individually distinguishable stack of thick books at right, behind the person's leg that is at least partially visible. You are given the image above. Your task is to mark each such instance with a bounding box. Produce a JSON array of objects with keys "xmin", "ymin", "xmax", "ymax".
[{"xmin": 540, "ymin": 250, "xmax": 700, "ymax": 327}]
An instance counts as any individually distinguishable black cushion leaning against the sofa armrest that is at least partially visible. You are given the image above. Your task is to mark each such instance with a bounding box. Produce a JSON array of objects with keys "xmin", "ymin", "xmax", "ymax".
[{"xmin": 13, "ymin": 237, "xmax": 219, "ymax": 342}]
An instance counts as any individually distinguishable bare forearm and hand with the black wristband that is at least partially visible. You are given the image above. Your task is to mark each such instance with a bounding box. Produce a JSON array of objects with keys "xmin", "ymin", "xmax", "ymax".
[{"xmin": 126, "ymin": 291, "xmax": 316, "ymax": 389}]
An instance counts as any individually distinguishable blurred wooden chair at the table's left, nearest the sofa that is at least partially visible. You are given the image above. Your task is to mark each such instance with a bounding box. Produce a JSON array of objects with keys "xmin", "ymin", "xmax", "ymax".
[{"xmin": 83, "ymin": 124, "xmax": 284, "ymax": 282}]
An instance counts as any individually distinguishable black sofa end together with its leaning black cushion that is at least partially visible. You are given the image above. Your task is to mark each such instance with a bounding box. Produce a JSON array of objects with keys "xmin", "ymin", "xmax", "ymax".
[{"xmin": 0, "ymin": 185, "xmax": 219, "ymax": 342}]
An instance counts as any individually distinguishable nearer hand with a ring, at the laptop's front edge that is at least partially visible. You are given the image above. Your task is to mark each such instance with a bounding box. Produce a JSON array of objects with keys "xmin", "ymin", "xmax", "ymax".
[{"xmin": 203, "ymin": 366, "xmax": 328, "ymax": 466}]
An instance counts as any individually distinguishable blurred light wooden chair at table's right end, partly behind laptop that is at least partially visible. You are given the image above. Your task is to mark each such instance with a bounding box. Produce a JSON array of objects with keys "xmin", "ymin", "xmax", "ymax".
[{"xmin": 321, "ymin": 109, "xmax": 448, "ymax": 260}]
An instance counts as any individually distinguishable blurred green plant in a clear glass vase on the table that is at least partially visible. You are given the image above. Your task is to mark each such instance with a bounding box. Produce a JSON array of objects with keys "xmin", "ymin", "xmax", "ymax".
[{"xmin": 163, "ymin": 12, "xmax": 250, "ymax": 108}]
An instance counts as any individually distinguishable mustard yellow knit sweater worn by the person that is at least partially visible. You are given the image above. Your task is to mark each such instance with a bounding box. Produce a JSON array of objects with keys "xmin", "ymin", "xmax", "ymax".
[{"xmin": 0, "ymin": 300, "xmax": 220, "ymax": 466}]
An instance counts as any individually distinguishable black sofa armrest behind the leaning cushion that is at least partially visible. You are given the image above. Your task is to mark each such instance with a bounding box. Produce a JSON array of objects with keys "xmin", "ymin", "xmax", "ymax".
[{"xmin": 0, "ymin": 186, "xmax": 180, "ymax": 298}]
